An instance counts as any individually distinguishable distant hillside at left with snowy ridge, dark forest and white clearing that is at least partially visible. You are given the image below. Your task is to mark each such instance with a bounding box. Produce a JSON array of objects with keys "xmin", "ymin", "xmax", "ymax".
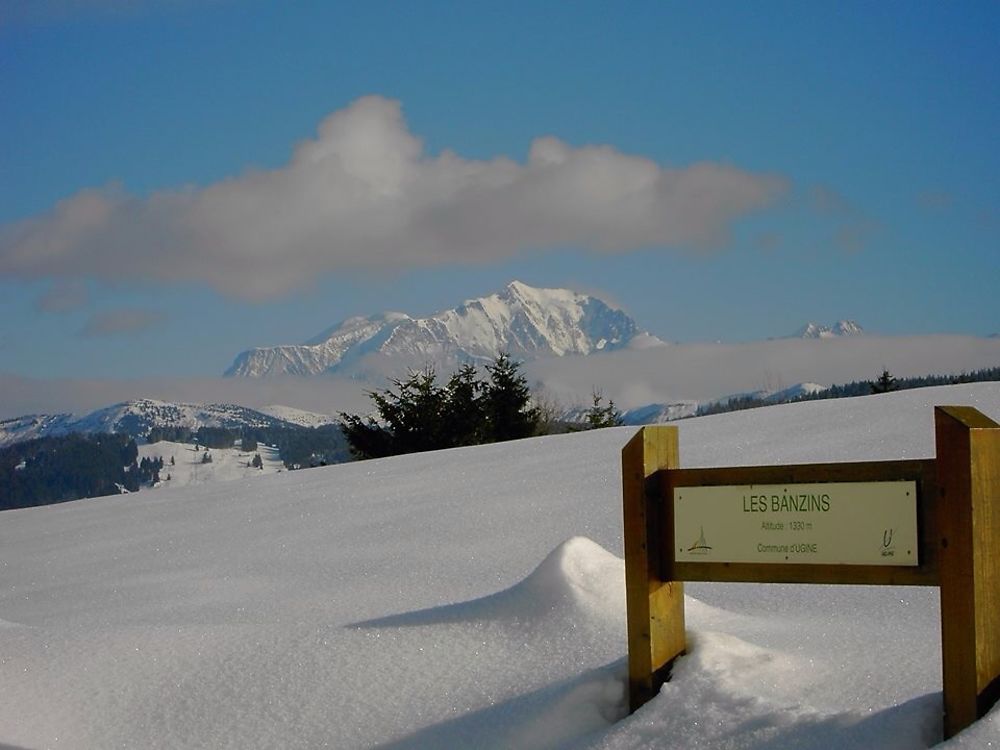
[{"xmin": 0, "ymin": 399, "xmax": 350, "ymax": 510}]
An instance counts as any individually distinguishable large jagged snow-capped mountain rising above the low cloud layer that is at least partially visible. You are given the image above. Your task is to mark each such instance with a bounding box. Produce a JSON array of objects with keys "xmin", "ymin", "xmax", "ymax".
[{"xmin": 225, "ymin": 281, "xmax": 662, "ymax": 378}]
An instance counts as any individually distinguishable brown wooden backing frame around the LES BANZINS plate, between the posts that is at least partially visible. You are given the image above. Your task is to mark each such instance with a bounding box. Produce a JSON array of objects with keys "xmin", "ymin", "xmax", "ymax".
[{"xmin": 656, "ymin": 459, "xmax": 940, "ymax": 586}]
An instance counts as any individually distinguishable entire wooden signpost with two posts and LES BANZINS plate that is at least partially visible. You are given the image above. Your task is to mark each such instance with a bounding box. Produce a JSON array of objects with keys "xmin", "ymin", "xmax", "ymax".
[{"xmin": 622, "ymin": 406, "xmax": 1000, "ymax": 738}]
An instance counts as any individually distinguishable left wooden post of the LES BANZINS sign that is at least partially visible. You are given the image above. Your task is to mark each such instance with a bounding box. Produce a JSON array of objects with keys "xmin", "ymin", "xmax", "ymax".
[{"xmin": 622, "ymin": 426, "xmax": 687, "ymax": 711}]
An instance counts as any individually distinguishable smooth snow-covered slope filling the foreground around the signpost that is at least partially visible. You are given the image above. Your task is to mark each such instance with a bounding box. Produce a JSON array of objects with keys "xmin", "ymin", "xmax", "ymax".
[{"xmin": 0, "ymin": 383, "xmax": 1000, "ymax": 750}]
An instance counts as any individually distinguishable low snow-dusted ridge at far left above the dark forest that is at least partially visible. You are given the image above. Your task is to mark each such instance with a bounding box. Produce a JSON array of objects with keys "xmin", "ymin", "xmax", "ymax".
[{"xmin": 0, "ymin": 399, "xmax": 304, "ymax": 447}]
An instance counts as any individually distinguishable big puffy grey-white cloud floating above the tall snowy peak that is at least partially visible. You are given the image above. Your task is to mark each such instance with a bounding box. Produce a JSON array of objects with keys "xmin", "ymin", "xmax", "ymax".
[{"xmin": 0, "ymin": 96, "xmax": 787, "ymax": 299}]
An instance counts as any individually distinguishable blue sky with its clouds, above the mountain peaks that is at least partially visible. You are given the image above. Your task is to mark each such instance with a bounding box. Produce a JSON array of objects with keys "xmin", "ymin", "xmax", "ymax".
[{"xmin": 0, "ymin": 0, "xmax": 1000, "ymax": 378}]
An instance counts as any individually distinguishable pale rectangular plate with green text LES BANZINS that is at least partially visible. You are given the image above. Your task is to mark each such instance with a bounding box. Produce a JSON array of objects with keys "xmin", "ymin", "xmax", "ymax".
[{"xmin": 673, "ymin": 482, "xmax": 918, "ymax": 566}]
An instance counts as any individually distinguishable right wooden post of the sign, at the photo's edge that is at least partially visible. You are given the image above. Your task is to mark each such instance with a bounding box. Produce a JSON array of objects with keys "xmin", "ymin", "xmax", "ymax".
[{"xmin": 934, "ymin": 406, "xmax": 1000, "ymax": 739}]
